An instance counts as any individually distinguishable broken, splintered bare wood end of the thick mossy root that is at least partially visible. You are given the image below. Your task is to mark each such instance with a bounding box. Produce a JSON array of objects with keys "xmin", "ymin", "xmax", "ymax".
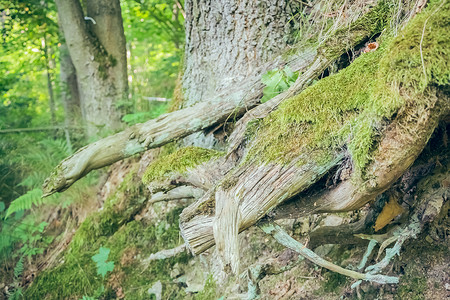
[{"xmin": 180, "ymin": 153, "xmax": 344, "ymax": 256}]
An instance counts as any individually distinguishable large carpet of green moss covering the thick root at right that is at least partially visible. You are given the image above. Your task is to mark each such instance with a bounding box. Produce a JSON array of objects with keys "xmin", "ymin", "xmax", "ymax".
[{"xmin": 247, "ymin": 3, "xmax": 450, "ymax": 171}]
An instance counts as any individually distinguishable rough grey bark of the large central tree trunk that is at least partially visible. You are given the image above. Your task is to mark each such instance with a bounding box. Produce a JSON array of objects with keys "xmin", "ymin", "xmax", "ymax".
[{"xmin": 183, "ymin": 0, "xmax": 299, "ymax": 106}]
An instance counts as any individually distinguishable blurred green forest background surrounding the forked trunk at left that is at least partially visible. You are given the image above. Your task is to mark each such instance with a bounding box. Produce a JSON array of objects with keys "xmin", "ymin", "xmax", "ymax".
[{"xmin": 0, "ymin": 0, "xmax": 184, "ymax": 292}]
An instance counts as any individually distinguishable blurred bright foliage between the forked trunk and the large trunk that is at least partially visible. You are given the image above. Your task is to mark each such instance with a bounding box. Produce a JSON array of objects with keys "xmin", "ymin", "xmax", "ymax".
[{"xmin": 121, "ymin": 0, "xmax": 184, "ymax": 119}]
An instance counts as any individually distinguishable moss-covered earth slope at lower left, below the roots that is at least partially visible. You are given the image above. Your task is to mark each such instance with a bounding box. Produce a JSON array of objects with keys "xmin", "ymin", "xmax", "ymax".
[{"xmin": 25, "ymin": 173, "xmax": 192, "ymax": 299}]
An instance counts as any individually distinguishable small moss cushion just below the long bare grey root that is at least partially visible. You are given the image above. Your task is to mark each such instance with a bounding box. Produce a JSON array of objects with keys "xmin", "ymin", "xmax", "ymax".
[{"xmin": 142, "ymin": 147, "xmax": 223, "ymax": 184}]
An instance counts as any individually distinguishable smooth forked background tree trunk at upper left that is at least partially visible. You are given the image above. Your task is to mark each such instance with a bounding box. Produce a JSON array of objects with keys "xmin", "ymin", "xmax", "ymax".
[{"xmin": 56, "ymin": 0, "xmax": 128, "ymax": 135}]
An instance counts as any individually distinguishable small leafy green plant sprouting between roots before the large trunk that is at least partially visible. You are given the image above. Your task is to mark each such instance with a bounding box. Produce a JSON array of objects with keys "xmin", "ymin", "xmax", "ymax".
[{"xmin": 261, "ymin": 66, "xmax": 298, "ymax": 103}]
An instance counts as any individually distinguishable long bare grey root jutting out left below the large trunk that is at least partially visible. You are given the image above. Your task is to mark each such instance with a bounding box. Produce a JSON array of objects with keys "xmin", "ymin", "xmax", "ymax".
[{"xmin": 43, "ymin": 44, "xmax": 315, "ymax": 196}]
